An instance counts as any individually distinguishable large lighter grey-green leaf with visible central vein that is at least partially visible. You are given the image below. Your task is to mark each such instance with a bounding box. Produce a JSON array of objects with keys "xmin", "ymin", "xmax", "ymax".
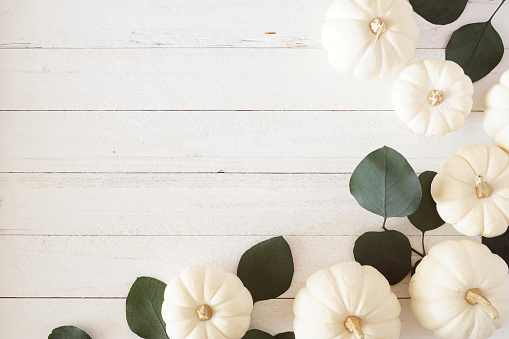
[{"xmin": 350, "ymin": 146, "xmax": 421, "ymax": 218}]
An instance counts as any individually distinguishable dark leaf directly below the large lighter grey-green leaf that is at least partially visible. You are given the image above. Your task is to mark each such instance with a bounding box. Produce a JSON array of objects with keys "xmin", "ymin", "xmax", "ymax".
[{"xmin": 353, "ymin": 231, "xmax": 412, "ymax": 285}]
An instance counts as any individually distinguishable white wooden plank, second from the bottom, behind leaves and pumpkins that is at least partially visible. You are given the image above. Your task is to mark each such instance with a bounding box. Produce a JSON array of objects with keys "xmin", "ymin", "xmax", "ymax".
[{"xmin": 0, "ymin": 235, "xmax": 463, "ymax": 298}]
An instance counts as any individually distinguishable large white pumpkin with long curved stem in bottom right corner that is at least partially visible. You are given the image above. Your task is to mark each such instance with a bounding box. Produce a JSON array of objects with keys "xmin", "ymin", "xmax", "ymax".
[{"xmin": 410, "ymin": 239, "xmax": 509, "ymax": 339}]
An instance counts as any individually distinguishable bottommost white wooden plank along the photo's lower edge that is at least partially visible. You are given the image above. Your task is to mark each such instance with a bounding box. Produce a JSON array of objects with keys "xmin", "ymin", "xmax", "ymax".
[{"xmin": 0, "ymin": 299, "xmax": 509, "ymax": 339}]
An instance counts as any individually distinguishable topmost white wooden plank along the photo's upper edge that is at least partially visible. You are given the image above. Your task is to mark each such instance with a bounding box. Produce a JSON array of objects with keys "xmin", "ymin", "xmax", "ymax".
[{"xmin": 0, "ymin": 0, "xmax": 509, "ymax": 48}]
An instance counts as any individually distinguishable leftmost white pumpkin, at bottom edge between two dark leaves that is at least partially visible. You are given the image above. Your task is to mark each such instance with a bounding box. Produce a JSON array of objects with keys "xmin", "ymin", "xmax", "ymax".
[{"xmin": 161, "ymin": 266, "xmax": 253, "ymax": 339}]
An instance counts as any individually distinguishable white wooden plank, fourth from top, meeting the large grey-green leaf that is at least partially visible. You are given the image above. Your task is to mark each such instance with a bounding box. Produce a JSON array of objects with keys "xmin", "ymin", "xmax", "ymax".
[{"xmin": 0, "ymin": 173, "xmax": 457, "ymax": 235}]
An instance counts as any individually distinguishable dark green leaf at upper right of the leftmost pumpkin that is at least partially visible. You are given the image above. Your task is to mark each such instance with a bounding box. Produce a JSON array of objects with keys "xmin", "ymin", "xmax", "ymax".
[{"xmin": 237, "ymin": 237, "xmax": 293, "ymax": 302}]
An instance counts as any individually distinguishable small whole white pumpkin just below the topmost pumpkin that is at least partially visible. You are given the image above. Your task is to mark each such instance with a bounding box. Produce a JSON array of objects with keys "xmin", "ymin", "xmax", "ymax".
[{"xmin": 392, "ymin": 59, "xmax": 474, "ymax": 136}]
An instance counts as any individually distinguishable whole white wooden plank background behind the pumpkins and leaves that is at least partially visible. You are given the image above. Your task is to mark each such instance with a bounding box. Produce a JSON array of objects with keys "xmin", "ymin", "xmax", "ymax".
[{"xmin": 0, "ymin": 0, "xmax": 509, "ymax": 339}]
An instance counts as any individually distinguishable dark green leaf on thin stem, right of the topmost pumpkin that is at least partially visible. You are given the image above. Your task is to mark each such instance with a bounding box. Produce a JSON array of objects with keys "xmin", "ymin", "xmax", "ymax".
[{"xmin": 445, "ymin": 21, "xmax": 504, "ymax": 82}]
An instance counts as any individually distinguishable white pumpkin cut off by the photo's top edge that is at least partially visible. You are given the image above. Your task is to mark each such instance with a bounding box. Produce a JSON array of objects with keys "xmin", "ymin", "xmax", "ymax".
[{"xmin": 322, "ymin": 0, "xmax": 419, "ymax": 79}]
